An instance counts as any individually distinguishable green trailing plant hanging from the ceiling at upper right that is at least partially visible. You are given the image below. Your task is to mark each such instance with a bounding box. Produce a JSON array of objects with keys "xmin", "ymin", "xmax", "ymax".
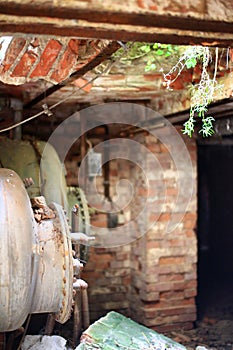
[{"xmin": 112, "ymin": 42, "xmax": 221, "ymax": 137}]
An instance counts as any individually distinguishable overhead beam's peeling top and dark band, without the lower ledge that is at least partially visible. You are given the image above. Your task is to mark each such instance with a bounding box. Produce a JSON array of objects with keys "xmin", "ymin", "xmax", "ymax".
[{"xmin": 0, "ymin": 0, "xmax": 233, "ymax": 33}]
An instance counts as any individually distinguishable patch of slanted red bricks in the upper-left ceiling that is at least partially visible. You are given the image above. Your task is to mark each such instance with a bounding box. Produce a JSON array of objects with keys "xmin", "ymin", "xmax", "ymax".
[{"xmin": 0, "ymin": 35, "xmax": 108, "ymax": 85}]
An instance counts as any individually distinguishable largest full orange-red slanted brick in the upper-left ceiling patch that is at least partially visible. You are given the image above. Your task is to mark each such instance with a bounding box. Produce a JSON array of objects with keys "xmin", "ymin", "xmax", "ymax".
[{"xmin": 30, "ymin": 39, "xmax": 62, "ymax": 78}]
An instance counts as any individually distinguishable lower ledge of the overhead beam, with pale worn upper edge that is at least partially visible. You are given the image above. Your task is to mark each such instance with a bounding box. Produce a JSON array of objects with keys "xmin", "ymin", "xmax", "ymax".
[{"xmin": 0, "ymin": 15, "xmax": 233, "ymax": 47}]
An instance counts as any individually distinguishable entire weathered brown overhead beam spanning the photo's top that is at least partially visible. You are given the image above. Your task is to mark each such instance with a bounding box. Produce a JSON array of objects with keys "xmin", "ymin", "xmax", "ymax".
[{"xmin": 0, "ymin": 0, "xmax": 233, "ymax": 46}]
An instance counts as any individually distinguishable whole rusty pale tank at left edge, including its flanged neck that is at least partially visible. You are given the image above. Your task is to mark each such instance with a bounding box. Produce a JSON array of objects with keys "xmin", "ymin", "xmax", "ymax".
[{"xmin": 0, "ymin": 168, "xmax": 73, "ymax": 332}]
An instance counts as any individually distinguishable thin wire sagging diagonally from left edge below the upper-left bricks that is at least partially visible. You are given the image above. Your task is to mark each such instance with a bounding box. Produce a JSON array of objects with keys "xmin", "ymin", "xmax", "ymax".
[{"xmin": 0, "ymin": 43, "xmax": 133, "ymax": 133}]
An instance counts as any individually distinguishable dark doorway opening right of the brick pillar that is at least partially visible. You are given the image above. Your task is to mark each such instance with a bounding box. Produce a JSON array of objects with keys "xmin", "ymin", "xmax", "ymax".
[{"xmin": 197, "ymin": 138, "xmax": 233, "ymax": 319}]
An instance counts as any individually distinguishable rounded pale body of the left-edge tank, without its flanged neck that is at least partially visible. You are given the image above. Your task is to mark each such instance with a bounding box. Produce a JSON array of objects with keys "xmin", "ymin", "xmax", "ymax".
[{"xmin": 0, "ymin": 169, "xmax": 36, "ymax": 331}]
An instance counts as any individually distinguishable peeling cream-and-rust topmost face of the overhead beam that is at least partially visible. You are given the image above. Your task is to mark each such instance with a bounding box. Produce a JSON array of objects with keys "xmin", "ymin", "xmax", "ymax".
[{"xmin": 0, "ymin": 0, "xmax": 233, "ymax": 22}]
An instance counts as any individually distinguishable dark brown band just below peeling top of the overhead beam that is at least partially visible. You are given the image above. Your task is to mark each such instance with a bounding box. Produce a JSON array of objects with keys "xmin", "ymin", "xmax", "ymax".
[{"xmin": 0, "ymin": 1, "xmax": 233, "ymax": 33}]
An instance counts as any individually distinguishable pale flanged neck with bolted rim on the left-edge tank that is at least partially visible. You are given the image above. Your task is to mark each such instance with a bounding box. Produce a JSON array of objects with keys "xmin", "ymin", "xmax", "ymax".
[{"xmin": 31, "ymin": 203, "xmax": 73, "ymax": 323}]
